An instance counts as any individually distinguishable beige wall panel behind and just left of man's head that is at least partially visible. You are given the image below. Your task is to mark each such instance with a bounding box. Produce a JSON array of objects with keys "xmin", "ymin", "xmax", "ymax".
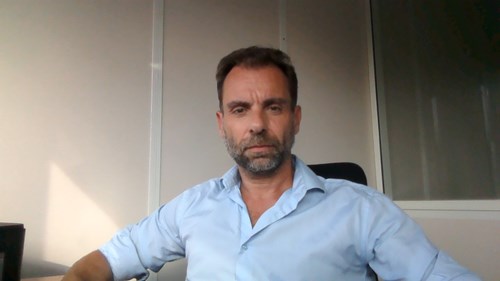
[{"xmin": 161, "ymin": 0, "xmax": 279, "ymax": 202}]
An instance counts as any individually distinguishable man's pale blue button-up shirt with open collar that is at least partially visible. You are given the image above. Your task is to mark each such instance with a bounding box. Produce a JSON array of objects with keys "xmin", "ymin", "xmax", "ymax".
[{"xmin": 100, "ymin": 158, "xmax": 480, "ymax": 281}]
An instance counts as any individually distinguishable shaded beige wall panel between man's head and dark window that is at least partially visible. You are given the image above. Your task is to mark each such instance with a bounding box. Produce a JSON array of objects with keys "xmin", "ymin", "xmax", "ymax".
[{"xmin": 287, "ymin": 0, "xmax": 375, "ymax": 186}]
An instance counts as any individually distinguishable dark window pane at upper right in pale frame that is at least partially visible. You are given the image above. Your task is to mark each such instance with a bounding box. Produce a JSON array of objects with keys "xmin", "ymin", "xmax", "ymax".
[{"xmin": 371, "ymin": 0, "xmax": 500, "ymax": 203}]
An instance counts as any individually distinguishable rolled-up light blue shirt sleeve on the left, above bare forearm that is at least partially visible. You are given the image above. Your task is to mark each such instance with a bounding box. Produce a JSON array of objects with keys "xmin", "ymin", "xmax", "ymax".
[{"xmin": 99, "ymin": 199, "xmax": 185, "ymax": 280}]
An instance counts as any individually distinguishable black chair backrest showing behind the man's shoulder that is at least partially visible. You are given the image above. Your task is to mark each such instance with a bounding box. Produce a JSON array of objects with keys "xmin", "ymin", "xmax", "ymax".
[{"xmin": 308, "ymin": 162, "xmax": 368, "ymax": 185}]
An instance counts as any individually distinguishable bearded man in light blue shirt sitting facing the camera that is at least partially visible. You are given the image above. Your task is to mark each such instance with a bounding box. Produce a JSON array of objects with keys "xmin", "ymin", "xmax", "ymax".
[{"xmin": 63, "ymin": 47, "xmax": 479, "ymax": 281}]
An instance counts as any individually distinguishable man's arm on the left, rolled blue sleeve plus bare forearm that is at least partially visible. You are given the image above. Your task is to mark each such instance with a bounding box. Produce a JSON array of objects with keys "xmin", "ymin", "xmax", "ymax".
[{"xmin": 63, "ymin": 192, "xmax": 188, "ymax": 281}]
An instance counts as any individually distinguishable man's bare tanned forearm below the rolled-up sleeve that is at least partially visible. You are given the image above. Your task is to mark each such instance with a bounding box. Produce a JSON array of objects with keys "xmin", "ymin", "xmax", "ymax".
[{"xmin": 62, "ymin": 250, "xmax": 113, "ymax": 281}]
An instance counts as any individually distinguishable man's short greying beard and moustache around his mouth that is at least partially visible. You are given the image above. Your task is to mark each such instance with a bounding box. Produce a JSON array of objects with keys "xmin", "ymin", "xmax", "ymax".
[{"xmin": 224, "ymin": 127, "xmax": 295, "ymax": 176}]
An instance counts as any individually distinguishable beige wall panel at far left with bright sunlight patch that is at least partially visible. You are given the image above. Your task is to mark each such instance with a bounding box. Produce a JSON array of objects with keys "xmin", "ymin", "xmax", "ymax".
[{"xmin": 0, "ymin": 0, "xmax": 152, "ymax": 277}]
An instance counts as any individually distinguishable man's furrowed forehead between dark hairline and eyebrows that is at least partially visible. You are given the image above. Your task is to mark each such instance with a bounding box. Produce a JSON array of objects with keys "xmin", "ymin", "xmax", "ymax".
[{"xmin": 222, "ymin": 66, "xmax": 290, "ymax": 102}]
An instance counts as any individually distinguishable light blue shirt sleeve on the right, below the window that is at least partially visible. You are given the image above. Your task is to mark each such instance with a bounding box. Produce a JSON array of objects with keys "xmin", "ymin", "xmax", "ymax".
[{"xmin": 367, "ymin": 192, "xmax": 481, "ymax": 281}]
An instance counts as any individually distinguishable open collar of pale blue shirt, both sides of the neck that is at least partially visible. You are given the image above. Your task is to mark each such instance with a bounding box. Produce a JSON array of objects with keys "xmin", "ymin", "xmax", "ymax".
[{"xmin": 220, "ymin": 155, "xmax": 325, "ymax": 191}]
